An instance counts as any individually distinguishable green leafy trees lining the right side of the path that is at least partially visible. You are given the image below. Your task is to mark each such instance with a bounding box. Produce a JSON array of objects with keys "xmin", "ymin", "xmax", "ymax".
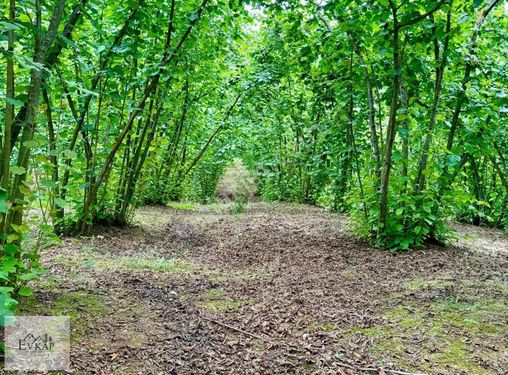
[{"xmin": 239, "ymin": 0, "xmax": 508, "ymax": 249}]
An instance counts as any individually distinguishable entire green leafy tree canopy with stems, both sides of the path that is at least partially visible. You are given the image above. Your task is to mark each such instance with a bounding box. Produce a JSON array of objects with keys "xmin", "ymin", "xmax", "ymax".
[{"xmin": 0, "ymin": 0, "xmax": 508, "ymax": 307}]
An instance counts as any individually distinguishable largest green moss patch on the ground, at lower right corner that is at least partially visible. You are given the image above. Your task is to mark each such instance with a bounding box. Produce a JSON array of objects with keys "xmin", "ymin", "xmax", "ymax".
[{"xmin": 348, "ymin": 278, "xmax": 508, "ymax": 374}]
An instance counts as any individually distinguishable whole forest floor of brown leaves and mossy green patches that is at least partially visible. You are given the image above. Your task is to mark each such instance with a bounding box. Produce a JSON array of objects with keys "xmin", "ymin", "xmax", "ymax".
[{"xmin": 11, "ymin": 203, "xmax": 508, "ymax": 375}]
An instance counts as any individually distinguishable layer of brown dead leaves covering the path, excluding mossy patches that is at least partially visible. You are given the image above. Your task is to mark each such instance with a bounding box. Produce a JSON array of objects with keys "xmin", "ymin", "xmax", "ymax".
[{"xmin": 9, "ymin": 204, "xmax": 508, "ymax": 374}]
